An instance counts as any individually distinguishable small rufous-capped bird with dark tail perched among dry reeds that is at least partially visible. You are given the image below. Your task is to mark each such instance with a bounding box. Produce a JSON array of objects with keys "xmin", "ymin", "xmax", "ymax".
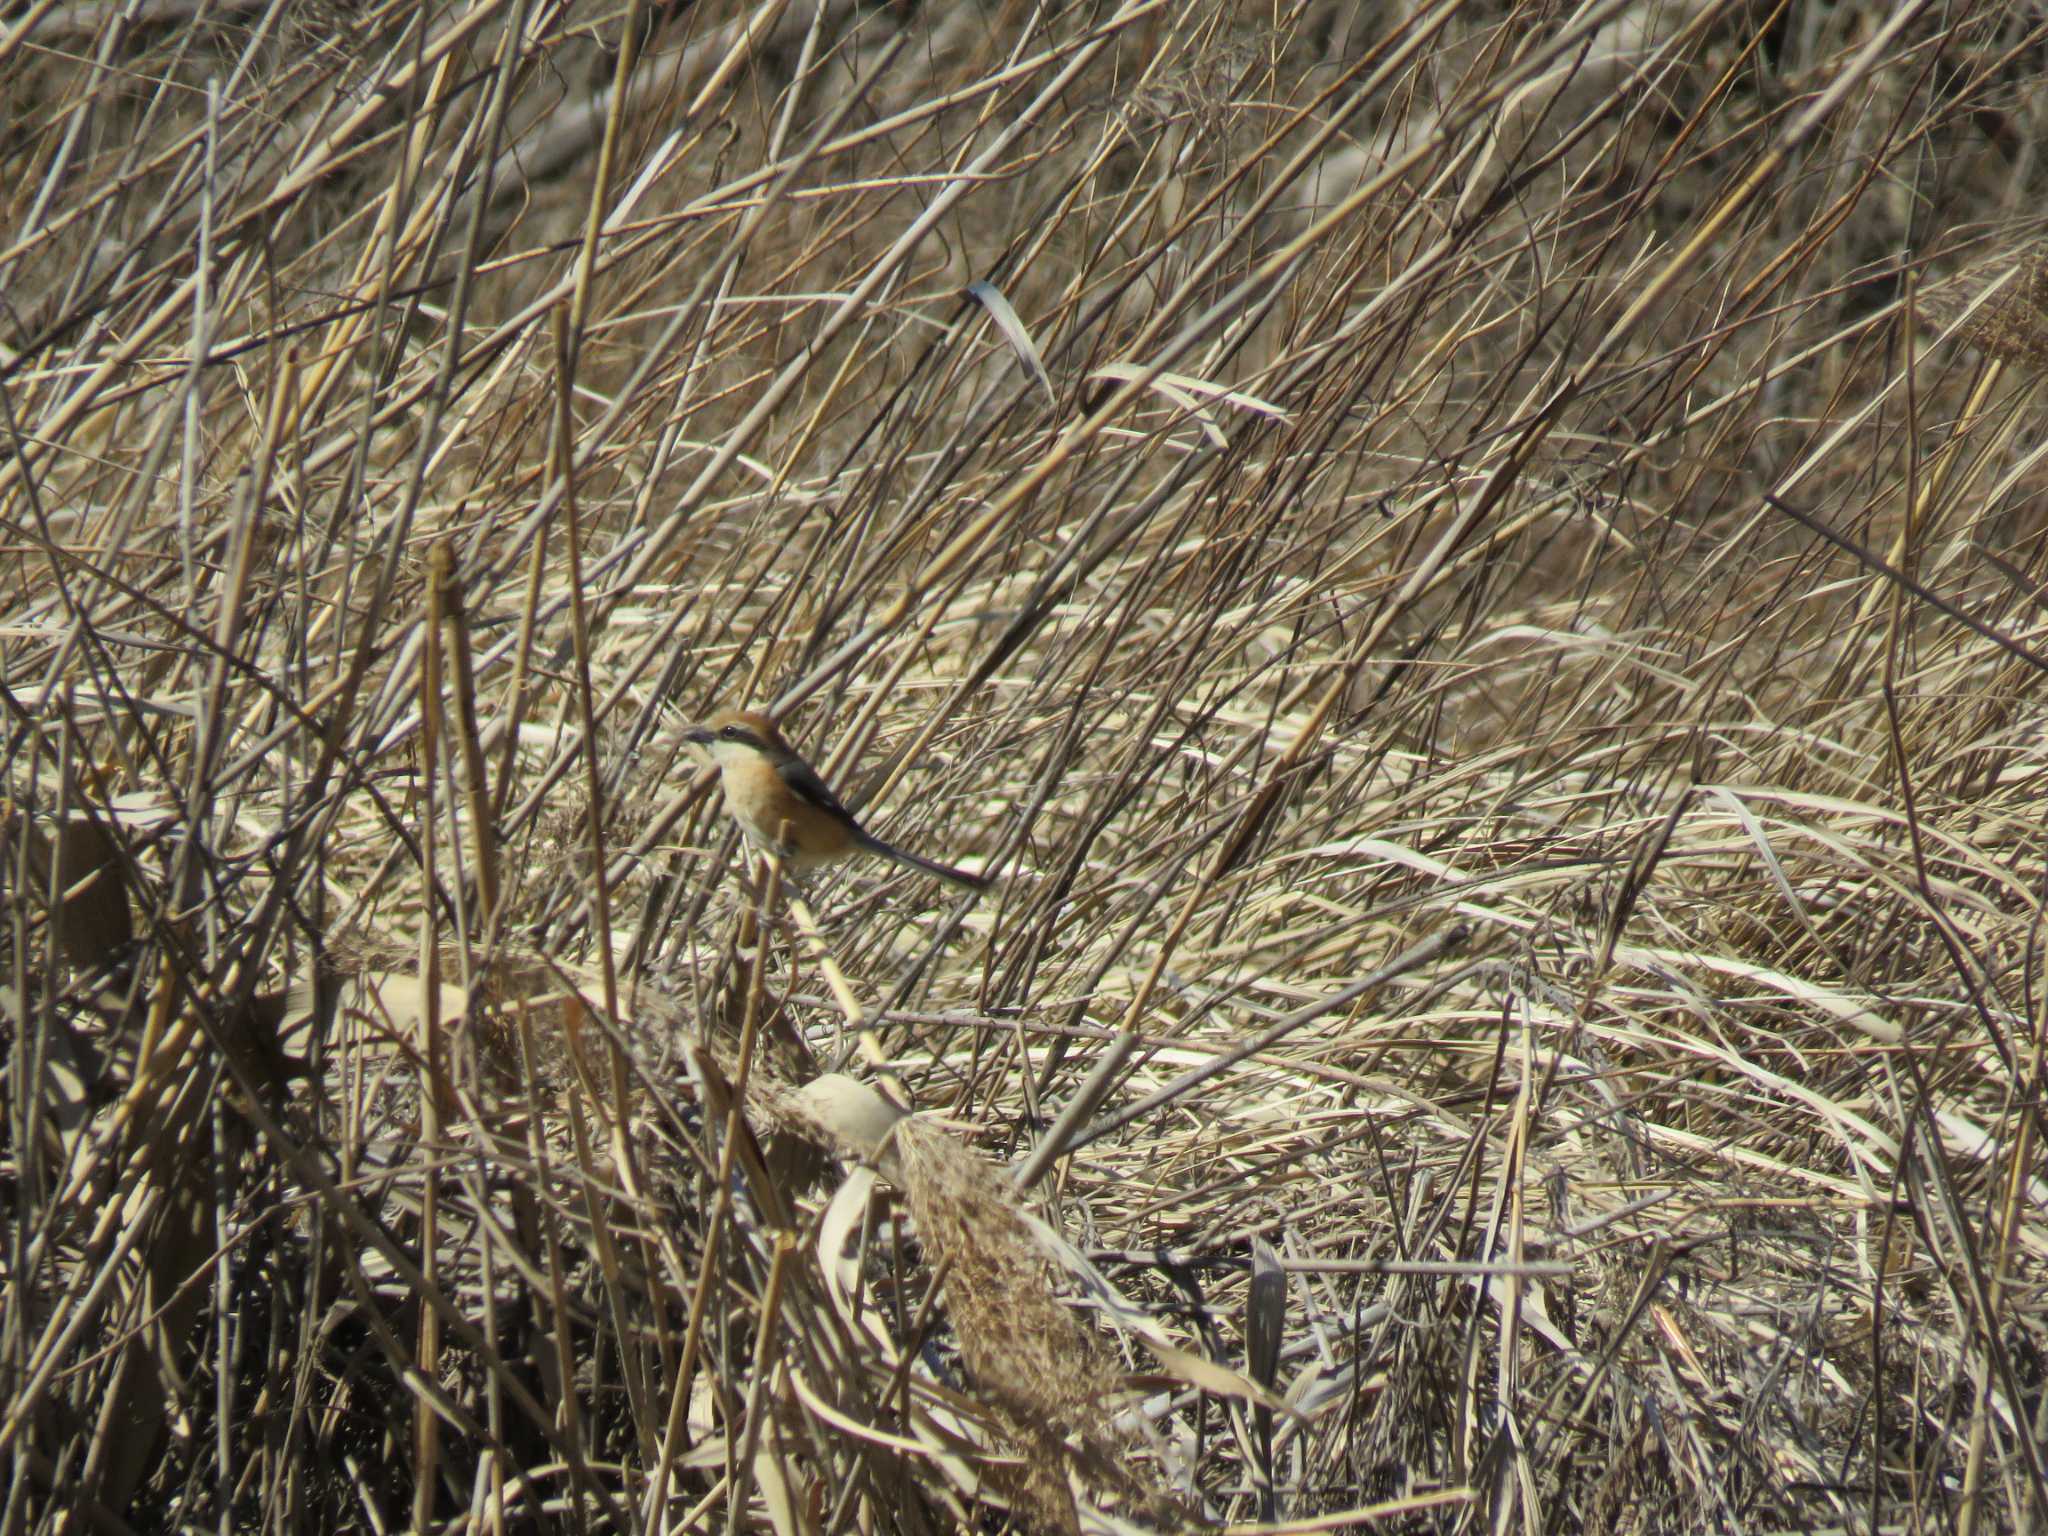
[{"xmin": 682, "ymin": 709, "xmax": 989, "ymax": 891}]
